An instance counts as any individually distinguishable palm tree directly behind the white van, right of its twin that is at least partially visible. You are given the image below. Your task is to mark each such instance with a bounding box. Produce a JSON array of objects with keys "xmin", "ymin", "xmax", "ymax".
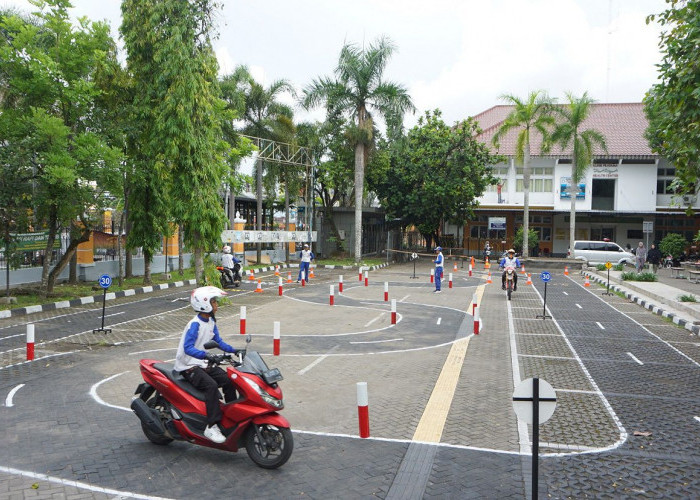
[{"xmin": 551, "ymin": 92, "xmax": 608, "ymax": 258}]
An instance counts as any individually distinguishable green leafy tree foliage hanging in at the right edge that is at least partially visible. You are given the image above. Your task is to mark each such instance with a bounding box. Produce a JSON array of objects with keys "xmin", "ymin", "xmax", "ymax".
[{"xmin": 644, "ymin": 0, "xmax": 700, "ymax": 209}]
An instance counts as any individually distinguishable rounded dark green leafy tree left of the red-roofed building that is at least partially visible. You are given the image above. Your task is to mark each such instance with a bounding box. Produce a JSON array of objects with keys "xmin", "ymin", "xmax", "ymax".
[{"xmin": 369, "ymin": 110, "xmax": 503, "ymax": 250}]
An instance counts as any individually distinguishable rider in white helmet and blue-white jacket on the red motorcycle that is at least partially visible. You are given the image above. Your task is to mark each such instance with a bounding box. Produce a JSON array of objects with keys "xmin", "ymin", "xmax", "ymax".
[{"xmin": 174, "ymin": 286, "xmax": 238, "ymax": 443}]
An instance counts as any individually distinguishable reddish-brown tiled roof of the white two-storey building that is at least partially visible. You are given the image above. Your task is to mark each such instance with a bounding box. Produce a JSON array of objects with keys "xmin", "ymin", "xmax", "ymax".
[{"xmin": 474, "ymin": 102, "xmax": 658, "ymax": 158}]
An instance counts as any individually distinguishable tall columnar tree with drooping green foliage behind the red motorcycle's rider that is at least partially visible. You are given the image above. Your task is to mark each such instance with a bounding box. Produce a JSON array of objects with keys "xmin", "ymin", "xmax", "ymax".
[{"xmin": 121, "ymin": 0, "xmax": 227, "ymax": 282}]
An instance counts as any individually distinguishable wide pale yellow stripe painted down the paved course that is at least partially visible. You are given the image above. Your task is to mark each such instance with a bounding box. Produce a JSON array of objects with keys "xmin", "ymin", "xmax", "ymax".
[{"xmin": 413, "ymin": 285, "xmax": 485, "ymax": 443}]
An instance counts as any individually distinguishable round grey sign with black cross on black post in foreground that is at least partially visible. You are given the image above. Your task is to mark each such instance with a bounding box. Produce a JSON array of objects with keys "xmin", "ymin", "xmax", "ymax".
[{"xmin": 513, "ymin": 377, "xmax": 557, "ymax": 498}]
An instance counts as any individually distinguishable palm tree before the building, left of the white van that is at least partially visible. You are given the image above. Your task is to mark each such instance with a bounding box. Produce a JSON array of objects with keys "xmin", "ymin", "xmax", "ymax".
[{"xmin": 492, "ymin": 90, "xmax": 554, "ymax": 257}]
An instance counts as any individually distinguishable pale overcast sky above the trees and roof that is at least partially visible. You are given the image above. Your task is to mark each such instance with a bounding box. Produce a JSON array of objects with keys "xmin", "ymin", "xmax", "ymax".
[{"xmin": 0, "ymin": 0, "xmax": 666, "ymax": 126}]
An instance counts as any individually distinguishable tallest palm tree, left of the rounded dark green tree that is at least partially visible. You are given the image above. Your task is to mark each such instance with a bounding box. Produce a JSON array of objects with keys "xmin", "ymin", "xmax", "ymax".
[{"xmin": 302, "ymin": 37, "xmax": 415, "ymax": 263}]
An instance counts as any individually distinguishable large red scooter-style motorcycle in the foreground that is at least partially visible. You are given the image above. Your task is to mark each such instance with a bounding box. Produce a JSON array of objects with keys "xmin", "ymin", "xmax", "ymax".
[{"xmin": 131, "ymin": 336, "xmax": 294, "ymax": 469}]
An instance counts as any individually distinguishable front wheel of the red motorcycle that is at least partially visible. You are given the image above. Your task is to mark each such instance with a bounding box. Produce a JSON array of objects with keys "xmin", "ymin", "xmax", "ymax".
[{"xmin": 245, "ymin": 424, "xmax": 294, "ymax": 469}]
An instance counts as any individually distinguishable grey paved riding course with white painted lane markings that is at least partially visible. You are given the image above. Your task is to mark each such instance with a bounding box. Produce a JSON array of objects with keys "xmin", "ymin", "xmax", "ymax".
[{"xmin": 0, "ymin": 261, "xmax": 700, "ymax": 498}]
